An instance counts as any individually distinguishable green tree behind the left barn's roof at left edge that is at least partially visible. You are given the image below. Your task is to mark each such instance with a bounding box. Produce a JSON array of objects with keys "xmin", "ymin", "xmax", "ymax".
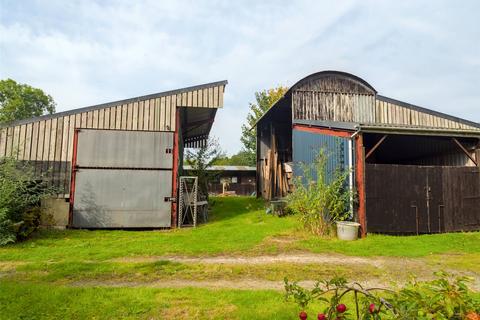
[{"xmin": 0, "ymin": 79, "xmax": 55, "ymax": 123}]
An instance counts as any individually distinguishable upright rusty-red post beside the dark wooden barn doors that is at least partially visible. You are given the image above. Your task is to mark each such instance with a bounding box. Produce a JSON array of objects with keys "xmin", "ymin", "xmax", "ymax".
[{"xmin": 355, "ymin": 133, "xmax": 367, "ymax": 238}]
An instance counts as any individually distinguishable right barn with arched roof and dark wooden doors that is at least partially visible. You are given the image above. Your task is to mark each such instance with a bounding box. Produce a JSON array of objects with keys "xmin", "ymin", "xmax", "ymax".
[{"xmin": 256, "ymin": 71, "xmax": 480, "ymax": 235}]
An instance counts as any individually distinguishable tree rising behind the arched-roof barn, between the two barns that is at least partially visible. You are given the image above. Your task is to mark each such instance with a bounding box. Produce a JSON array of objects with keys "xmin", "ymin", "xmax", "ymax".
[{"xmin": 240, "ymin": 86, "xmax": 288, "ymax": 166}]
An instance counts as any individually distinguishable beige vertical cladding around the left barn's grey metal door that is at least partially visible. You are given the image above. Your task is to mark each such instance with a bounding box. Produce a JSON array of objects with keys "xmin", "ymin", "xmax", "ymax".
[{"xmin": 0, "ymin": 83, "xmax": 225, "ymax": 196}]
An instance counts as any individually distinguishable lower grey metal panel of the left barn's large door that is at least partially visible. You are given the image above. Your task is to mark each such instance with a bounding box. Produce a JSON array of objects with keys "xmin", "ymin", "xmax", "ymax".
[{"xmin": 73, "ymin": 169, "xmax": 172, "ymax": 228}]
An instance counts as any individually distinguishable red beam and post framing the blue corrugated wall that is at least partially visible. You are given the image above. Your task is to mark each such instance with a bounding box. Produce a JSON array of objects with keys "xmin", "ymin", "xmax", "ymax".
[{"xmin": 293, "ymin": 124, "xmax": 367, "ymax": 238}]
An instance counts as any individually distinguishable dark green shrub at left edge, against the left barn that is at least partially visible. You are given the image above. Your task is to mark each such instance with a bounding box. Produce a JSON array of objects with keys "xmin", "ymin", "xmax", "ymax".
[{"xmin": 0, "ymin": 157, "xmax": 55, "ymax": 245}]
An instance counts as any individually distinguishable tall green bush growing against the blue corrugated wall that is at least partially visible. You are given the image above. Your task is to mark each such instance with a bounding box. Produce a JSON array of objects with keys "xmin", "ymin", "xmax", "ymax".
[{"xmin": 287, "ymin": 149, "xmax": 354, "ymax": 236}]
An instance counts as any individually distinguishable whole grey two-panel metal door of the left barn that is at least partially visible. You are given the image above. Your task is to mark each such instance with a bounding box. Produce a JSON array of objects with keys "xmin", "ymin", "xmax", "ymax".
[{"xmin": 72, "ymin": 129, "xmax": 174, "ymax": 228}]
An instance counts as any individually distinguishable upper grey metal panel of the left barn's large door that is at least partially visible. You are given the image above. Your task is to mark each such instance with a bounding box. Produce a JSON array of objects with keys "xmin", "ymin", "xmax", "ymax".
[{"xmin": 77, "ymin": 129, "xmax": 173, "ymax": 169}]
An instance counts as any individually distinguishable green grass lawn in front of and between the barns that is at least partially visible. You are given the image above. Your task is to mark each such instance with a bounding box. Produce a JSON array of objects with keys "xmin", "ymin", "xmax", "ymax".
[{"xmin": 0, "ymin": 197, "xmax": 480, "ymax": 319}]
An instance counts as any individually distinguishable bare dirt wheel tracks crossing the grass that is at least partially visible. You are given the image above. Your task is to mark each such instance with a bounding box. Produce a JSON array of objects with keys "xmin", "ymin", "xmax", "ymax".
[{"xmin": 101, "ymin": 253, "xmax": 480, "ymax": 291}]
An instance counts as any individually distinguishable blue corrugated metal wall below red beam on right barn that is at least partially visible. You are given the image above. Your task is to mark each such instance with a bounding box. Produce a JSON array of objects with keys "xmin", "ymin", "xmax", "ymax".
[{"xmin": 293, "ymin": 130, "xmax": 353, "ymax": 179}]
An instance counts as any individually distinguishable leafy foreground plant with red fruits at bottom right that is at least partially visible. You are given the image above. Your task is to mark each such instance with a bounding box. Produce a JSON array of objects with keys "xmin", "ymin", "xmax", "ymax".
[{"xmin": 285, "ymin": 272, "xmax": 480, "ymax": 320}]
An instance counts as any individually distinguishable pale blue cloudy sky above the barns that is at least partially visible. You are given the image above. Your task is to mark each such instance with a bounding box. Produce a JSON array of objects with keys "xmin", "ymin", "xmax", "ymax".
[{"xmin": 0, "ymin": 0, "xmax": 480, "ymax": 154}]
